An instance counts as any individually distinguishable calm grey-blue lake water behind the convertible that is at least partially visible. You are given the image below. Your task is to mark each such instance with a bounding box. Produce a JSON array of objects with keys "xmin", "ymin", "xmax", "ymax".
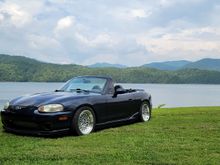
[{"xmin": 0, "ymin": 82, "xmax": 220, "ymax": 108}]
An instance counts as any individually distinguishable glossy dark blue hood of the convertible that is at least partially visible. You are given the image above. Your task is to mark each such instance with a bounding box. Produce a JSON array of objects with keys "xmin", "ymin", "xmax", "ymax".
[{"xmin": 10, "ymin": 92, "xmax": 100, "ymax": 107}]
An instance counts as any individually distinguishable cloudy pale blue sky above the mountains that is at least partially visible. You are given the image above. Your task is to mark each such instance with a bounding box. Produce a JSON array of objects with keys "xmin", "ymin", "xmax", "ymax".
[{"xmin": 0, "ymin": 0, "xmax": 220, "ymax": 66}]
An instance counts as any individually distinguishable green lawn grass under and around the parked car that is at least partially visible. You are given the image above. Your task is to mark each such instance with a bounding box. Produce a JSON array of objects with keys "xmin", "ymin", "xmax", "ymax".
[{"xmin": 0, "ymin": 107, "xmax": 220, "ymax": 165}]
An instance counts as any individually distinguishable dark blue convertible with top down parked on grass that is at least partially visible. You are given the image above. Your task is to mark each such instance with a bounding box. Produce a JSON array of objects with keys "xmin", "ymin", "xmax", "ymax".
[{"xmin": 1, "ymin": 76, "xmax": 152, "ymax": 135}]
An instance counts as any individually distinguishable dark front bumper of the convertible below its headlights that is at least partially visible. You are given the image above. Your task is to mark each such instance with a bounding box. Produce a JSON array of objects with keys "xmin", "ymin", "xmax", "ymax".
[{"xmin": 1, "ymin": 110, "xmax": 72, "ymax": 135}]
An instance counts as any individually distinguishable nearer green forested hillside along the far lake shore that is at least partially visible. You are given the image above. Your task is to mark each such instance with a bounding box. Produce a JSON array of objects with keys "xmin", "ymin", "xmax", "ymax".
[{"xmin": 0, "ymin": 55, "xmax": 220, "ymax": 84}]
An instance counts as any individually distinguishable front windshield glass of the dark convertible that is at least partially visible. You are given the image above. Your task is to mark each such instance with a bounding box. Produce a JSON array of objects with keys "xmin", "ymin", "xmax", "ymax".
[{"xmin": 58, "ymin": 77, "xmax": 107, "ymax": 93}]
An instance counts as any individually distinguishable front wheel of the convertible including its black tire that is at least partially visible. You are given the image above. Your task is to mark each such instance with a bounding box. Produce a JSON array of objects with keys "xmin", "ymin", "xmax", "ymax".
[{"xmin": 72, "ymin": 106, "xmax": 96, "ymax": 136}]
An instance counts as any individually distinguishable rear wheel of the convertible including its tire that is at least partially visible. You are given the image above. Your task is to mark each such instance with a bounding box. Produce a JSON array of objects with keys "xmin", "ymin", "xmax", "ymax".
[{"xmin": 140, "ymin": 101, "xmax": 151, "ymax": 122}]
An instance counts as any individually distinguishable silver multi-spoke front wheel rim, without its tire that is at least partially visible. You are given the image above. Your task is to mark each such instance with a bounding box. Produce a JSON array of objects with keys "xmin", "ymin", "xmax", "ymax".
[{"xmin": 78, "ymin": 110, "xmax": 94, "ymax": 135}]
